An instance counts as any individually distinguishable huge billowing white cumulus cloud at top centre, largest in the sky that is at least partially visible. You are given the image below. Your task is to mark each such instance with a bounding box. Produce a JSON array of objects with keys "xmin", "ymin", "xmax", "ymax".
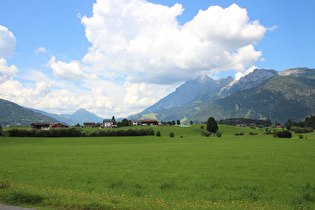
[{"xmin": 81, "ymin": 0, "xmax": 267, "ymax": 84}]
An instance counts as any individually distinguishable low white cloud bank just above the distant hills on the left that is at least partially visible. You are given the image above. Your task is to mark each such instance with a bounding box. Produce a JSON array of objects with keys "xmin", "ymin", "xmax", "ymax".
[{"xmin": 0, "ymin": 76, "xmax": 114, "ymax": 116}]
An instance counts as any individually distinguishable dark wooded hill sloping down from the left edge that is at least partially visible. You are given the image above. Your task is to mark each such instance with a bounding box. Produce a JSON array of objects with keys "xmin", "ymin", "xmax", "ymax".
[{"xmin": 0, "ymin": 99, "xmax": 59, "ymax": 127}]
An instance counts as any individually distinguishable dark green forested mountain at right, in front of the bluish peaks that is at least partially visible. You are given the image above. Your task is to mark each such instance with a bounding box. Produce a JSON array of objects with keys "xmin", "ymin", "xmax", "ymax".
[{"xmin": 192, "ymin": 75, "xmax": 315, "ymax": 123}]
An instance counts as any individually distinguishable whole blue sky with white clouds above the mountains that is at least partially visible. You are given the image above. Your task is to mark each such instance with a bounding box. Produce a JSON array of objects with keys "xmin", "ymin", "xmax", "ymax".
[{"xmin": 0, "ymin": 0, "xmax": 315, "ymax": 118}]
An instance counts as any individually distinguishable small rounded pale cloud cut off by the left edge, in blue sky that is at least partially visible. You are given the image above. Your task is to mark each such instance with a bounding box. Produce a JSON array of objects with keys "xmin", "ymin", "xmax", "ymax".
[{"xmin": 0, "ymin": 25, "xmax": 16, "ymax": 57}]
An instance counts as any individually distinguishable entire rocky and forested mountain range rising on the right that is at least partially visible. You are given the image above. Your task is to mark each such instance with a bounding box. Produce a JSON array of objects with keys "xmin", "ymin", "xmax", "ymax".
[{"xmin": 128, "ymin": 68, "xmax": 315, "ymax": 123}]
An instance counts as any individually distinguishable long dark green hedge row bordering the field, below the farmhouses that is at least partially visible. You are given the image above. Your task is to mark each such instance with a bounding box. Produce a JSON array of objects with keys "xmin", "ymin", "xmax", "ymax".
[{"xmin": 6, "ymin": 128, "xmax": 154, "ymax": 137}]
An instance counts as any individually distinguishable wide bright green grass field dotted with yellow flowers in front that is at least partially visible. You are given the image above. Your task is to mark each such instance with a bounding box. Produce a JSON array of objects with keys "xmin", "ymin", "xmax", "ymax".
[{"xmin": 0, "ymin": 125, "xmax": 315, "ymax": 209}]
